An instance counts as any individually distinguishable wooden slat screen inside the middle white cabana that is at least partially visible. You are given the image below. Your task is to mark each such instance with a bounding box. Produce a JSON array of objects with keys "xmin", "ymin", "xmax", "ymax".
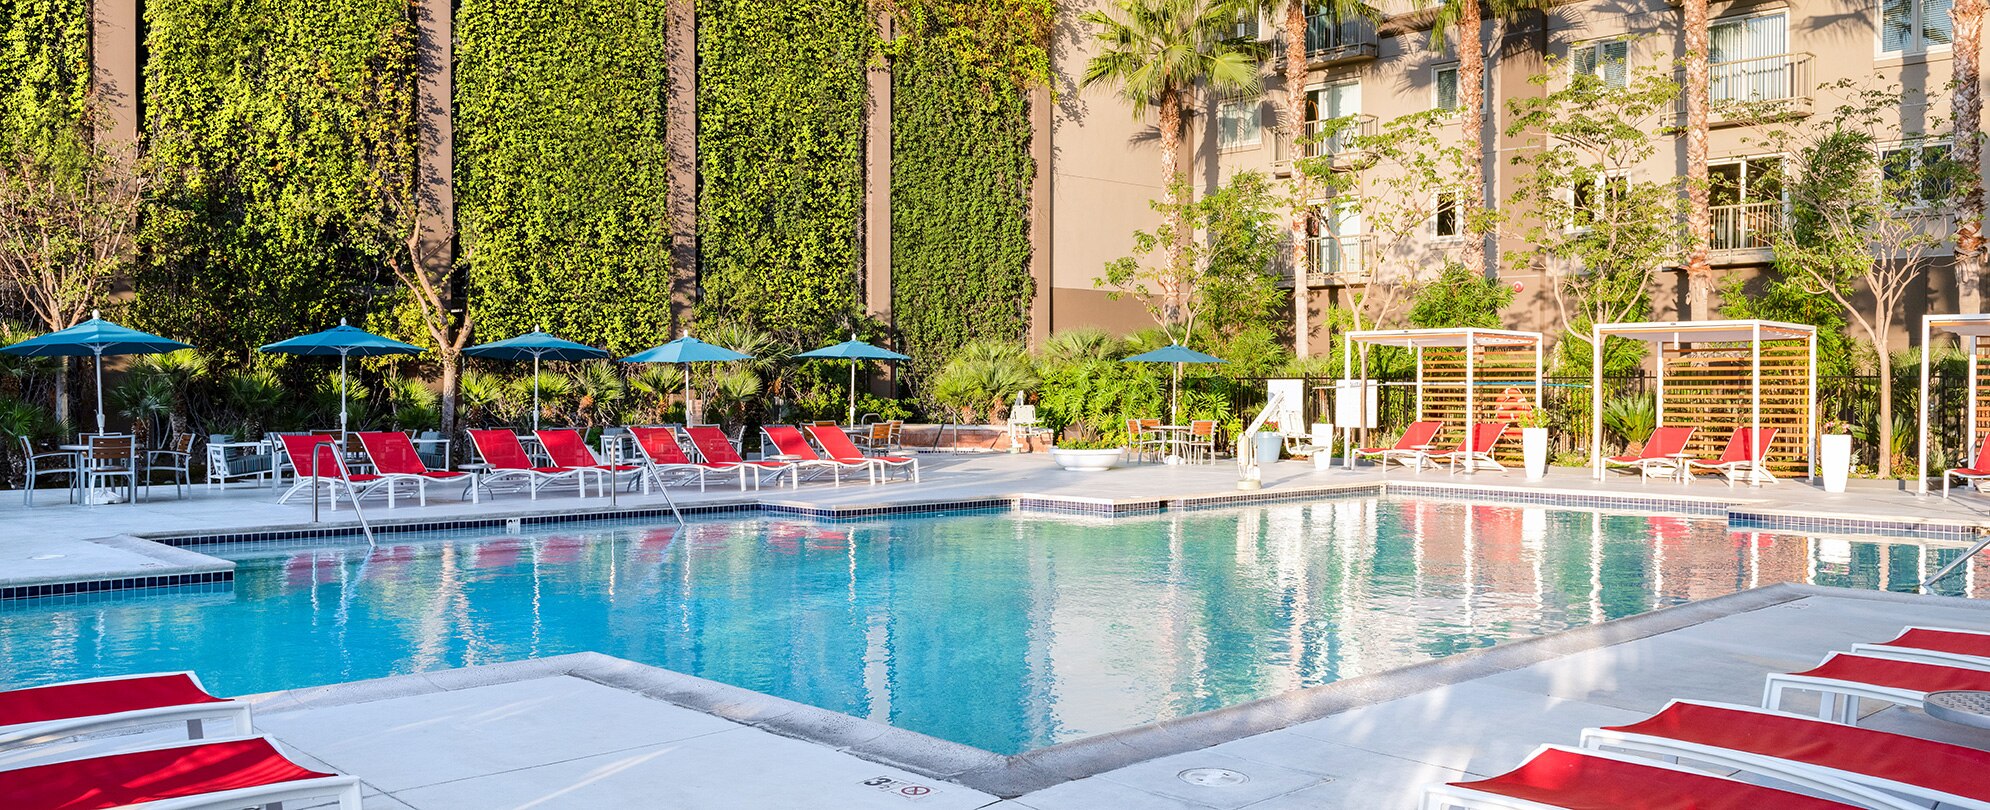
[{"xmin": 1658, "ymin": 340, "xmax": 1815, "ymax": 478}]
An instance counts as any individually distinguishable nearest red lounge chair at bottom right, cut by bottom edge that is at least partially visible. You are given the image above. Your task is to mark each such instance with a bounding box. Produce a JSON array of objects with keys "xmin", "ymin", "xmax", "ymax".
[{"xmin": 1421, "ymin": 746, "xmax": 1878, "ymax": 810}]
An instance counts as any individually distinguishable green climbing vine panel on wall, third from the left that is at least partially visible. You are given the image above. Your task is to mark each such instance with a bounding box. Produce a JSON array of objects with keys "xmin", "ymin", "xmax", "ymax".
[{"xmin": 456, "ymin": 0, "xmax": 671, "ymax": 352}]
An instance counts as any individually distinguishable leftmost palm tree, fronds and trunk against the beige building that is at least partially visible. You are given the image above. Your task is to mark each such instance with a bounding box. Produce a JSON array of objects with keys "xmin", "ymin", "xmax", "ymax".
[{"xmin": 1079, "ymin": 0, "xmax": 1258, "ymax": 310}]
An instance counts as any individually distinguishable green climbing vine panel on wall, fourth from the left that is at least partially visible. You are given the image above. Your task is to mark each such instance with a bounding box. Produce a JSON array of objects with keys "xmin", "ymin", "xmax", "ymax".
[{"xmin": 698, "ymin": 0, "xmax": 878, "ymax": 344}]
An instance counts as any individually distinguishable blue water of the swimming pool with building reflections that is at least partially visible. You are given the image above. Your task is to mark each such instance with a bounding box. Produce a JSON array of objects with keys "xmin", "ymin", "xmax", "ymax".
[{"xmin": 0, "ymin": 498, "xmax": 1966, "ymax": 754}]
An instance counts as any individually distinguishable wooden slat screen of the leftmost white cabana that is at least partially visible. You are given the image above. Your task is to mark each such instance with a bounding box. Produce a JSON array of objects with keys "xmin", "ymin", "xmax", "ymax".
[{"xmin": 1417, "ymin": 346, "xmax": 1540, "ymax": 464}]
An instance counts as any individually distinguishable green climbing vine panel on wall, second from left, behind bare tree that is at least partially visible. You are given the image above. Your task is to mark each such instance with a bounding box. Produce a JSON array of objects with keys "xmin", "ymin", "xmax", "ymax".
[{"xmin": 131, "ymin": 0, "xmax": 416, "ymax": 360}]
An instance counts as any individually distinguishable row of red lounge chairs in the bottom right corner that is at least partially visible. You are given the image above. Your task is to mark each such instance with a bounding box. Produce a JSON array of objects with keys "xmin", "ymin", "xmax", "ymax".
[{"xmin": 1421, "ymin": 627, "xmax": 1990, "ymax": 810}]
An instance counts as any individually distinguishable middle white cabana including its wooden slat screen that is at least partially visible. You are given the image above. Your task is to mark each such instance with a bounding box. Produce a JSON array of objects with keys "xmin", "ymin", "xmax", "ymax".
[{"xmin": 1590, "ymin": 320, "xmax": 1817, "ymax": 480}]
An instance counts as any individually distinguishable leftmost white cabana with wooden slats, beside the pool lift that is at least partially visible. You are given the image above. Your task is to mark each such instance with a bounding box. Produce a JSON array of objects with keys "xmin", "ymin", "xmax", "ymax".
[{"xmin": 1337, "ymin": 328, "xmax": 1542, "ymax": 466}]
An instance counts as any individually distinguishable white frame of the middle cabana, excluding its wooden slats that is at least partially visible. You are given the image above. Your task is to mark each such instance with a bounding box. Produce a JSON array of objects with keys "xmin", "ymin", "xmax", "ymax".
[{"xmin": 1590, "ymin": 320, "xmax": 1817, "ymax": 482}]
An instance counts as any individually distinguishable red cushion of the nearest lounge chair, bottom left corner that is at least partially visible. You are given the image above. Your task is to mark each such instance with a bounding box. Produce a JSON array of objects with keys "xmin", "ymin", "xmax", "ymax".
[{"xmin": 0, "ymin": 738, "xmax": 332, "ymax": 810}]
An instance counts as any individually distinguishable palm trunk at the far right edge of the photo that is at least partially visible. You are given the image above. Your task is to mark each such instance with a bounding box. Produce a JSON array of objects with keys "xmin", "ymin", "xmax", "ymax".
[{"xmin": 1948, "ymin": 0, "xmax": 1984, "ymax": 312}]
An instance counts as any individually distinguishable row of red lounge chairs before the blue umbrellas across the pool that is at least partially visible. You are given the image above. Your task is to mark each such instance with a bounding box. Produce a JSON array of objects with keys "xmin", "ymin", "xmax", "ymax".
[{"xmin": 279, "ymin": 424, "xmax": 919, "ymax": 507}]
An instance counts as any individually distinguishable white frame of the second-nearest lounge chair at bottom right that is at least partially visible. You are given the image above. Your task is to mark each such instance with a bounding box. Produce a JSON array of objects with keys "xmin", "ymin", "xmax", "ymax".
[{"xmin": 1582, "ymin": 701, "xmax": 1990, "ymax": 810}]
